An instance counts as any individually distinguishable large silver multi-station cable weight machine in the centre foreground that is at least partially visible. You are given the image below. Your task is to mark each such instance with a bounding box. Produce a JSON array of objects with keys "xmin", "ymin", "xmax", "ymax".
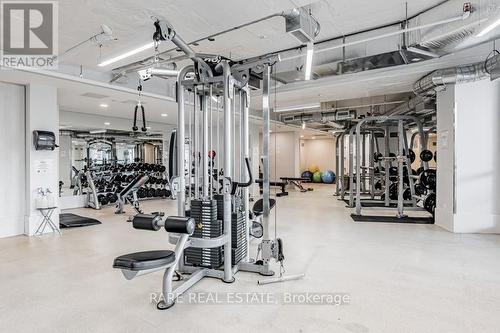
[{"xmin": 114, "ymin": 19, "xmax": 304, "ymax": 310}]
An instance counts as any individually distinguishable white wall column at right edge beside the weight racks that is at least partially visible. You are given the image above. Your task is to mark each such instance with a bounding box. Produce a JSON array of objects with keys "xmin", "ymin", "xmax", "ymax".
[{"xmin": 436, "ymin": 80, "xmax": 500, "ymax": 233}]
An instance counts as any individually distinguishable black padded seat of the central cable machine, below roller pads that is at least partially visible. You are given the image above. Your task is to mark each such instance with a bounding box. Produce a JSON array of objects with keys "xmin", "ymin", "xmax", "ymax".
[{"xmin": 113, "ymin": 250, "xmax": 175, "ymax": 271}]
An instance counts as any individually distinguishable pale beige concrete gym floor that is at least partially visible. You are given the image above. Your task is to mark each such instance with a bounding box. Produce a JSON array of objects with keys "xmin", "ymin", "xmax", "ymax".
[{"xmin": 0, "ymin": 186, "xmax": 500, "ymax": 333}]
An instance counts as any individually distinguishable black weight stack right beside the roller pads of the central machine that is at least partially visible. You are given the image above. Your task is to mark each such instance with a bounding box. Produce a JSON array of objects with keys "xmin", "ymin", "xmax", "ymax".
[{"xmin": 184, "ymin": 200, "xmax": 224, "ymax": 268}]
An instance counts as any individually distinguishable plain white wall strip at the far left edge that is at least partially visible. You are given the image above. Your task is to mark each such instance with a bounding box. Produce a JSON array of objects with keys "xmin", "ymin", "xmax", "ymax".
[{"xmin": 0, "ymin": 82, "xmax": 26, "ymax": 238}]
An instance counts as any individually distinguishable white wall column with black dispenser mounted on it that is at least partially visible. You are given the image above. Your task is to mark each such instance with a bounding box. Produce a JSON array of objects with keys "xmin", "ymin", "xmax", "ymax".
[{"xmin": 24, "ymin": 84, "xmax": 59, "ymax": 235}]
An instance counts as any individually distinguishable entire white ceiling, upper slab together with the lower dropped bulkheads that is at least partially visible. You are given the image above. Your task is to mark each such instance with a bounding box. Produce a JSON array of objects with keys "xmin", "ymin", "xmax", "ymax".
[{"xmin": 0, "ymin": 0, "xmax": 498, "ymax": 124}]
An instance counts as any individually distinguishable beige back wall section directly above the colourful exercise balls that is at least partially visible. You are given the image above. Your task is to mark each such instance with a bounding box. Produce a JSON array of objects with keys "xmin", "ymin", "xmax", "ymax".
[{"xmin": 300, "ymin": 138, "xmax": 336, "ymax": 172}]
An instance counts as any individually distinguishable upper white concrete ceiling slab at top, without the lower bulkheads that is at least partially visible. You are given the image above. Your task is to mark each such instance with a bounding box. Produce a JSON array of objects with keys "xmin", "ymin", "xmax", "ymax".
[{"xmin": 59, "ymin": 0, "xmax": 441, "ymax": 69}]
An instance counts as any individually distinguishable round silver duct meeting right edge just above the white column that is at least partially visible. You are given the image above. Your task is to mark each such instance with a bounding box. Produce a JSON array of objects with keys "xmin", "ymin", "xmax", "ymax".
[{"xmin": 413, "ymin": 54, "xmax": 500, "ymax": 96}]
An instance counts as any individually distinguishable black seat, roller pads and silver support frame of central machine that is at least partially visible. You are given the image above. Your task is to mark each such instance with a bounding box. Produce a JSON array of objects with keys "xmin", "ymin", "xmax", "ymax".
[{"xmin": 113, "ymin": 214, "xmax": 195, "ymax": 310}]
